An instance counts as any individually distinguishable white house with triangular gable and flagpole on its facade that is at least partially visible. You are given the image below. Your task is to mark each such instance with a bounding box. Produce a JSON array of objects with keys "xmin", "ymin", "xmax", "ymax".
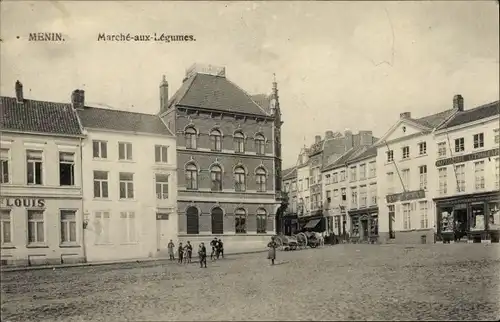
[{"xmin": 375, "ymin": 98, "xmax": 460, "ymax": 244}]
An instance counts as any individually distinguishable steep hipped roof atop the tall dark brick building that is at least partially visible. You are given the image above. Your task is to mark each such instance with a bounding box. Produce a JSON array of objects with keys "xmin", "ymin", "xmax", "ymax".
[{"xmin": 173, "ymin": 73, "xmax": 270, "ymax": 116}]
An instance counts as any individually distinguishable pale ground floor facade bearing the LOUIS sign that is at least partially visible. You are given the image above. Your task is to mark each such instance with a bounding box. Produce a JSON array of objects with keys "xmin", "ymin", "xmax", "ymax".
[{"xmin": 0, "ymin": 196, "xmax": 85, "ymax": 266}]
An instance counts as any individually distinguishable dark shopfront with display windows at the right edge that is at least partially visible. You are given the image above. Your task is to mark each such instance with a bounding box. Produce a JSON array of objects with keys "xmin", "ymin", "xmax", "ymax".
[{"xmin": 434, "ymin": 191, "xmax": 500, "ymax": 243}]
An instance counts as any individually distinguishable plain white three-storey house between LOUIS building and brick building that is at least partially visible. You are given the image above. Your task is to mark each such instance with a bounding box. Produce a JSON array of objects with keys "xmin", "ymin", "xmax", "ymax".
[{"xmin": 72, "ymin": 90, "xmax": 177, "ymax": 261}]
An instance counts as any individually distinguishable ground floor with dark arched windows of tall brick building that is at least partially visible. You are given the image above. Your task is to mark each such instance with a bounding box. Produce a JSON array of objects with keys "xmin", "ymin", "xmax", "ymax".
[{"xmin": 176, "ymin": 201, "xmax": 280, "ymax": 252}]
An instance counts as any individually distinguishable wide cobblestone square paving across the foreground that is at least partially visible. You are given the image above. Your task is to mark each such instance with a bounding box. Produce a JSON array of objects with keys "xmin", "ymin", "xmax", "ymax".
[{"xmin": 1, "ymin": 244, "xmax": 500, "ymax": 321}]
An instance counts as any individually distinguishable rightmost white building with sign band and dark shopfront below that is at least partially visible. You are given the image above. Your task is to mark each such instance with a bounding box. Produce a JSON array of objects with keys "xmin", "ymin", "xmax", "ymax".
[{"xmin": 429, "ymin": 96, "xmax": 500, "ymax": 243}]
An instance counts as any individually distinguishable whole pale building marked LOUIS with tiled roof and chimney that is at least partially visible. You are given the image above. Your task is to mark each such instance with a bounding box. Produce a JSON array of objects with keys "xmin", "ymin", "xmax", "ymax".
[{"xmin": 0, "ymin": 82, "xmax": 85, "ymax": 266}]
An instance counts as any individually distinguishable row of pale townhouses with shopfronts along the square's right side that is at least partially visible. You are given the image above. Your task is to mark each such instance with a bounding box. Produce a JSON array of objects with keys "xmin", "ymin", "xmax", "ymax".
[{"xmin": 284, "ymin": 95, "xmax": 500, "ymax": 243}]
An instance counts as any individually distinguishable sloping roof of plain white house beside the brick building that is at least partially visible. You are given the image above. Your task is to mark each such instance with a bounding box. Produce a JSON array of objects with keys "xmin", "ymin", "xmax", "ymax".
[{"xmin": 77, "ymin": 106, "xmax": 173, "ymax": 136}]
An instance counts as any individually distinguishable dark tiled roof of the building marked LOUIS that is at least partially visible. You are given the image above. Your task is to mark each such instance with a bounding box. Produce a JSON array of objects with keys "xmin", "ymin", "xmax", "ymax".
[{"xmin": 0, "ymin": 96, "xmax": 83, "ymax": 136}]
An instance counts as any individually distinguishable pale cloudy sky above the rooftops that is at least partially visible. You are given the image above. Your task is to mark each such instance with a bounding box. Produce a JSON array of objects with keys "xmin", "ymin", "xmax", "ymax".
[{"xmin": 0, "ymin": 1, "xmax": 500, "ymax": 167}]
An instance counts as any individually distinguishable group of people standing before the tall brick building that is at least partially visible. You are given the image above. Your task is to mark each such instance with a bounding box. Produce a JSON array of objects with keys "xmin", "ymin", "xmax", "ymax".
[{"xmin": 167, "ymin": 238, "xmax": 224, "ymax": 268}]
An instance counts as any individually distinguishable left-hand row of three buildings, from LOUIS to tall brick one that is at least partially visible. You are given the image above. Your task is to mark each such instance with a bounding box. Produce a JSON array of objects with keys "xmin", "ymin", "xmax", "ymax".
[{"xmin": 0, "ymin": 65, "xmax": 282, "ymax": 266}]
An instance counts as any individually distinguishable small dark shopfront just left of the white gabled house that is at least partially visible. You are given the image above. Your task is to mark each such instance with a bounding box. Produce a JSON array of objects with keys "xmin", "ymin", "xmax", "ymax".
[{"xmin": 348, "ymin": 207, "xmax": 378, "ymax": 244}]
